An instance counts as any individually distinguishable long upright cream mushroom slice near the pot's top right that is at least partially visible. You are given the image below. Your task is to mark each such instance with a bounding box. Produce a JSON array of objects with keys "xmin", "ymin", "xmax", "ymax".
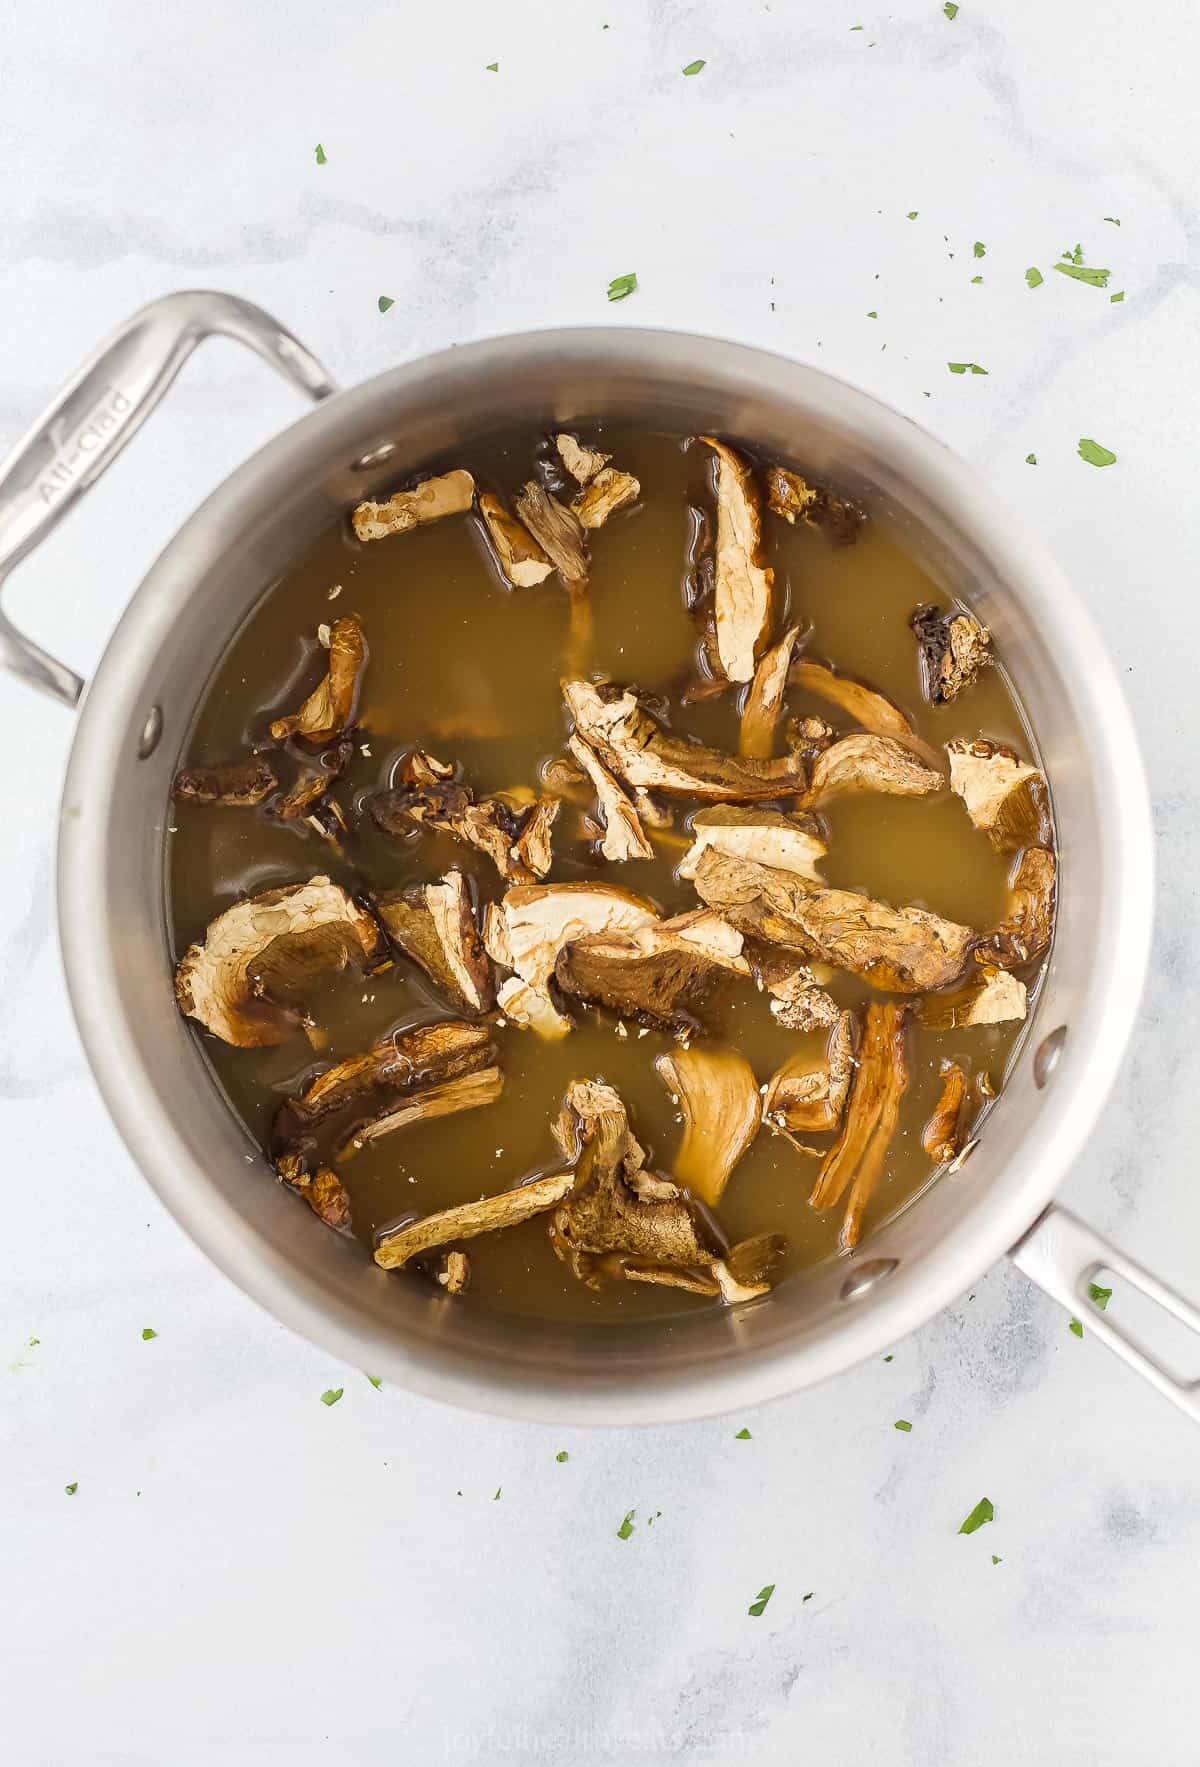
[{"xmin": 700, "ymin": 436, "xmax": 774, "ymax": 680}]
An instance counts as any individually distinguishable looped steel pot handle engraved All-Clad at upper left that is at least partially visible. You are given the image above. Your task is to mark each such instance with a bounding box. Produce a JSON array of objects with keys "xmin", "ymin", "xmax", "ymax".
[{"xmin": 0, "ymin": 290, "xmax": 338, "ymax": 707}]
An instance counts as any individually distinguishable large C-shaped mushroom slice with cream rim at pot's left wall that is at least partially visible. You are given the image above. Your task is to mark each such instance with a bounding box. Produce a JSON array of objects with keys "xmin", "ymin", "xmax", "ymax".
[{"xmin": 175, "ymin": 876, "xmax": 387, "ymax": 1050}]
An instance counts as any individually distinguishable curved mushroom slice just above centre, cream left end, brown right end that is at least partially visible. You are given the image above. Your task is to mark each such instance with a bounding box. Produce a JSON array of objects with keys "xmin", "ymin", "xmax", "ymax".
[{"xmin": 562, "ymin": 677, "xmax": 808, "ymax": 804}]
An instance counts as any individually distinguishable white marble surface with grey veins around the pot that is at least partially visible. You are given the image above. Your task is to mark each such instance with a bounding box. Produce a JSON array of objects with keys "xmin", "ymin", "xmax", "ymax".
[{"xmin": 0, "ymin": 0, "xmax": 1200, "ymax": 1767}]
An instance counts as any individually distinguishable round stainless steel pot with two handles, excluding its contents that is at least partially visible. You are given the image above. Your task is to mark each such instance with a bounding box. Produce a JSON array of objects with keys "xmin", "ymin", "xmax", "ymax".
[{"xmin": 0, "ymin": 292, "xmax": 1200, "ymax": 1424}]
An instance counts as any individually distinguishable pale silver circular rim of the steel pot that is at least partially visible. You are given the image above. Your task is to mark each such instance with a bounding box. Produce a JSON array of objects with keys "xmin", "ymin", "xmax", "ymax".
[{"xmin": 58, "ymin": 325, "xmax": 1154, "ymax": 1426}]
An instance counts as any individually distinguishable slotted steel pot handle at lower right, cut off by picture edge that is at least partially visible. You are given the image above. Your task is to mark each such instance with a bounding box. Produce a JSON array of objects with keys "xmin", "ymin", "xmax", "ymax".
[{"xmin": 1009, "ymin": 1203, "xmax": 1200, "ymax": 1422}]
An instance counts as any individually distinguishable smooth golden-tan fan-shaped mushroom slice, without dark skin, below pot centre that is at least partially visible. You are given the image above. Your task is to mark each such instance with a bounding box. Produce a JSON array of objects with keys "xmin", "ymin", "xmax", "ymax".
[{"xmin": 654, "ymin": 1048, "xmax": 762, "ymax": 1209}]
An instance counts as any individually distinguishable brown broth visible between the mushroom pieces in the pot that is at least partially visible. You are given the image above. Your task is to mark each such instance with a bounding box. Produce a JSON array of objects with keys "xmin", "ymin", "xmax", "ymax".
[{"xmin": 168, "ymin": 424, "xmax": 1053, "ymax": 1320}]
